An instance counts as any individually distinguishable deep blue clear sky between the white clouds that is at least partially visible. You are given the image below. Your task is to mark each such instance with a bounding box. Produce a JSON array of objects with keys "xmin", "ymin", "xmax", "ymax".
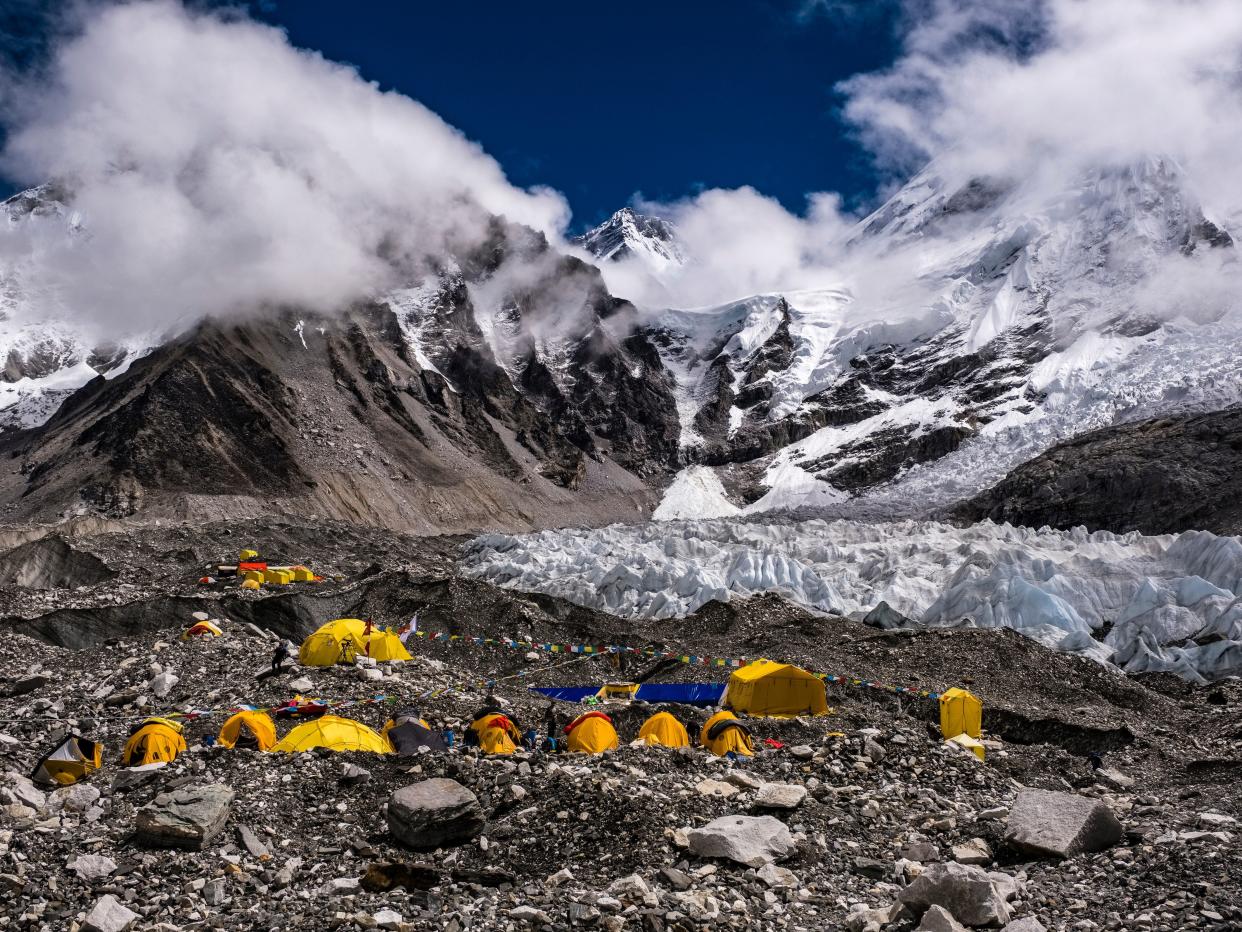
[{"xmin": 0, "ymin": 0, "xmax": 897, "ymax": 229}]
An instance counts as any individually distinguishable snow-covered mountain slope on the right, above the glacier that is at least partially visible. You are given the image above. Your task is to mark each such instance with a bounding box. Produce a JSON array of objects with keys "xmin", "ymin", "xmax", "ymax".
[{"xmin": 648, "ymin": 159, "xmax": 1242, "ymax": 526}]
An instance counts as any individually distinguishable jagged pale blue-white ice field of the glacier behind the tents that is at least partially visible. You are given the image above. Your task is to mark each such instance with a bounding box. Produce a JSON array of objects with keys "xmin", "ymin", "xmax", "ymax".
[{"xmin": 462, "ymin": 519, "xmax": 1242, "ymax": 682}]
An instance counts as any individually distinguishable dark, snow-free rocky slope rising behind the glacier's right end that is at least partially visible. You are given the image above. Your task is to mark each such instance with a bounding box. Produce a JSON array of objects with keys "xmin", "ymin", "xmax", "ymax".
[{"xmin": 958, "ymin": 408, "xmax": 1242, "ymax": 534}]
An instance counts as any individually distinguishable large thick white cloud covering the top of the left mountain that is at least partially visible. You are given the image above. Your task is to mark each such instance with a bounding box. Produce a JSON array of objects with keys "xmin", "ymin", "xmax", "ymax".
[{"xmin": 0, "ymin": 0, "xmax": 569, "ymax": 333}]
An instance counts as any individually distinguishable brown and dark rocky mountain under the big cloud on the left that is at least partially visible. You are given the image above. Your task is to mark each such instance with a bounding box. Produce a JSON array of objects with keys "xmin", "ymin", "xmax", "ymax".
[{"xmin": 0, "ymin": 195, "xmax": 677, "ymax": 531}]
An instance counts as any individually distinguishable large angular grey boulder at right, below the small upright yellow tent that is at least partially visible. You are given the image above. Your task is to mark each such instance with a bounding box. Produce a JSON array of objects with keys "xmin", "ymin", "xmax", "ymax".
[{"xmin": 1005, "ymin": 789, "xmax": 1122, "ymax": 857}]
